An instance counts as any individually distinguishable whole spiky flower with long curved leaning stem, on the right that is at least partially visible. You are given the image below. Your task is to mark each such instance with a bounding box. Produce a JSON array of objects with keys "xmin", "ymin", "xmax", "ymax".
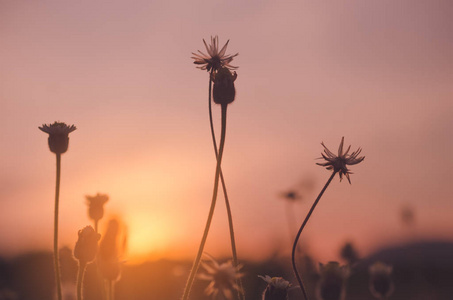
[{"xmin": 291, "ymin": 137, "xmax": 365, "ymax": 299}]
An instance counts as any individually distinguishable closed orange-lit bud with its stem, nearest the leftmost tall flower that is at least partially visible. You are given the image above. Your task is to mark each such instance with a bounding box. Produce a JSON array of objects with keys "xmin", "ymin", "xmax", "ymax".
[{"xmin": 74, "ymin": 226, "xmax": 101, "ymax": 300}]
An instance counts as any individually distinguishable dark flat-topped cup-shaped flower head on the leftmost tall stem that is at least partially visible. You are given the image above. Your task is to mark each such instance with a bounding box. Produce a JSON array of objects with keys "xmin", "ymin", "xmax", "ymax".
[{"xmin": 39, "ymin": 122, "xmax": 77, "ymax": 154}]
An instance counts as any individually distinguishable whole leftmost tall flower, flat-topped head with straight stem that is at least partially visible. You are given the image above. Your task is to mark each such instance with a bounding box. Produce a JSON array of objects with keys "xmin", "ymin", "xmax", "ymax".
[{"xmin": 38, "ymin": 122, "xmax": 77, "ymax": 300}]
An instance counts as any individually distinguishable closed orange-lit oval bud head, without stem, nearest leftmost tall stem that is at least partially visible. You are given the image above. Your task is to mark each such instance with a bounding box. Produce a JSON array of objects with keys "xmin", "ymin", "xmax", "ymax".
[{"xmin": 74, "ymin": 226, "xmax": 101, "ymax": 263}]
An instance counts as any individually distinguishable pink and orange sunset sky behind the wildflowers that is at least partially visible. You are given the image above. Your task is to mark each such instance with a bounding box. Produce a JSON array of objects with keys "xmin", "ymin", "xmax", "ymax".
[{"xmin": 0, "ymin": 0, "xmax": 453, "ymax": 261}]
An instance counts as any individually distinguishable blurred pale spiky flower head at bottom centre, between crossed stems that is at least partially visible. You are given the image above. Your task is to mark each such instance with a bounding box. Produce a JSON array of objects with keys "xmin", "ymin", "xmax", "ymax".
[{"xmin": 198, "ymin": 257, "xmax": 243, "ymax": 299}]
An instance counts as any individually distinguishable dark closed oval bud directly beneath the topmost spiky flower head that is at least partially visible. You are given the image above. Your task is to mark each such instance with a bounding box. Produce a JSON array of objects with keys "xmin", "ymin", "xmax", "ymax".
[{"xmin": 212, "ymin": 67, "xmax": 237, "ymax": 105}]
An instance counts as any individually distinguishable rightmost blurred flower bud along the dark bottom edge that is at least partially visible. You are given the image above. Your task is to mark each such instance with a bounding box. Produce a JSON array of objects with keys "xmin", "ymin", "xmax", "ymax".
[{"xmin": 368, "ymin": 262, "xmax": 395, "ymax": 299}]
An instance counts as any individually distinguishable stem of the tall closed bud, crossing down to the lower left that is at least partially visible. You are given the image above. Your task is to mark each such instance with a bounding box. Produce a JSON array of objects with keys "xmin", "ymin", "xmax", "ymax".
[{"xmin": 182, "ymin": 105, "xmax": 227, "ymax": 300}]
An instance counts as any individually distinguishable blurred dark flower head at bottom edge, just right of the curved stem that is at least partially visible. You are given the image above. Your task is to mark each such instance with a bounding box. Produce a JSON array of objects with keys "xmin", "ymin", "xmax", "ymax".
[{"xmin": 316, "ymin": 261, "xmax": 349, "ymax": 300}]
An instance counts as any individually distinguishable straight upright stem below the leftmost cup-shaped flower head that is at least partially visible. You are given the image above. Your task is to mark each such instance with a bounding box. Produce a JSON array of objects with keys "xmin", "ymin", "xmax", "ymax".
[{"xmin": 53, "ymin": 153, "xmax": 62, "ymax": 300}]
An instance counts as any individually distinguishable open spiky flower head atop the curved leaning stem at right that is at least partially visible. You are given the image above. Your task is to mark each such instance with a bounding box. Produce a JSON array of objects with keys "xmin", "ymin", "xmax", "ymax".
[{"xmin": 317, "ymin": 137, "xmax": 365, "ymax": 183}]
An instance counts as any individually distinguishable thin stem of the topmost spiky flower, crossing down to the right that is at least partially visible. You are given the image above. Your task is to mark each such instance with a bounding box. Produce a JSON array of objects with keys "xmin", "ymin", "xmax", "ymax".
[{"xmin": 208, "ymin": 70, "xmax": 245, "ymax": 299}]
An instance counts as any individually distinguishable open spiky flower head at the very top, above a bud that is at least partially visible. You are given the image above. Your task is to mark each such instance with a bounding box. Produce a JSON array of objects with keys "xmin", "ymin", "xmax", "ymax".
[{"xmin": 191, "ymin": 36, "xmax": 239, "ymax": 72}]
